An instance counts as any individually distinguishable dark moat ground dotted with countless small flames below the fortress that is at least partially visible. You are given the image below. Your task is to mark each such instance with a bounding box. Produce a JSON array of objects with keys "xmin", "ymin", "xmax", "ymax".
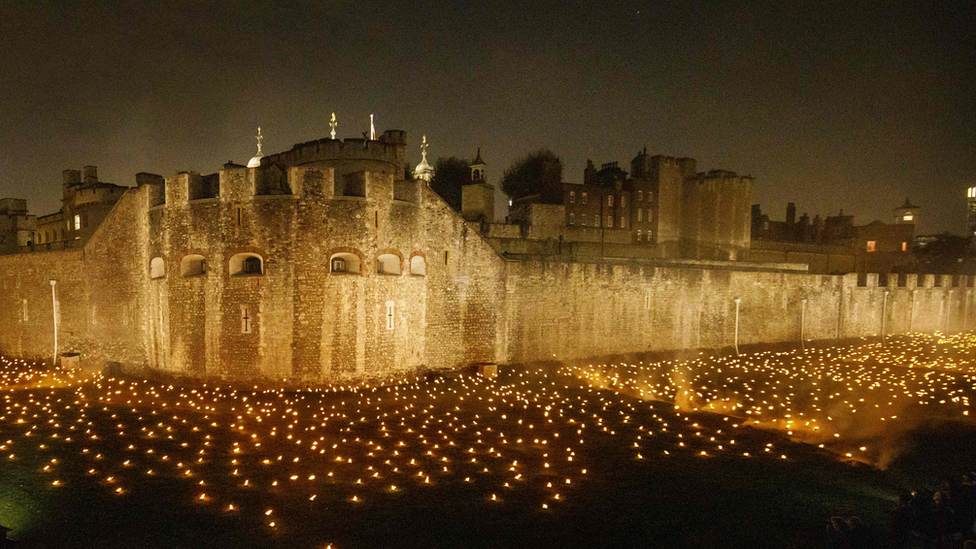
[{"xmin": 0, "ymin": 333, "xmax": 976, "ymax": 549}]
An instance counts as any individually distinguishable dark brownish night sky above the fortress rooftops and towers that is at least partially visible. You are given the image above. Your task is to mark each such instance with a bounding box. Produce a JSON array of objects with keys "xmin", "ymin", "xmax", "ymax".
[{"xmin": 0, "ymin": 0, "xmax": 976, "ymax": 233}]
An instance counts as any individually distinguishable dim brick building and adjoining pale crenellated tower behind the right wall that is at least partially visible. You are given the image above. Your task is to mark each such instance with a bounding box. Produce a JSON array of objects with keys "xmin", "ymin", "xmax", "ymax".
[{"xmin": 496, "ymin": 149, "xmax": 753, "ymax": 261}]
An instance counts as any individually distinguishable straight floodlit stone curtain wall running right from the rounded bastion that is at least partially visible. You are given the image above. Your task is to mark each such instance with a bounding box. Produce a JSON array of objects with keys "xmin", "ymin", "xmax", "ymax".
[{"xmin": 506, "ymin": 261, "xmax": 976, "ymax": 361}]
